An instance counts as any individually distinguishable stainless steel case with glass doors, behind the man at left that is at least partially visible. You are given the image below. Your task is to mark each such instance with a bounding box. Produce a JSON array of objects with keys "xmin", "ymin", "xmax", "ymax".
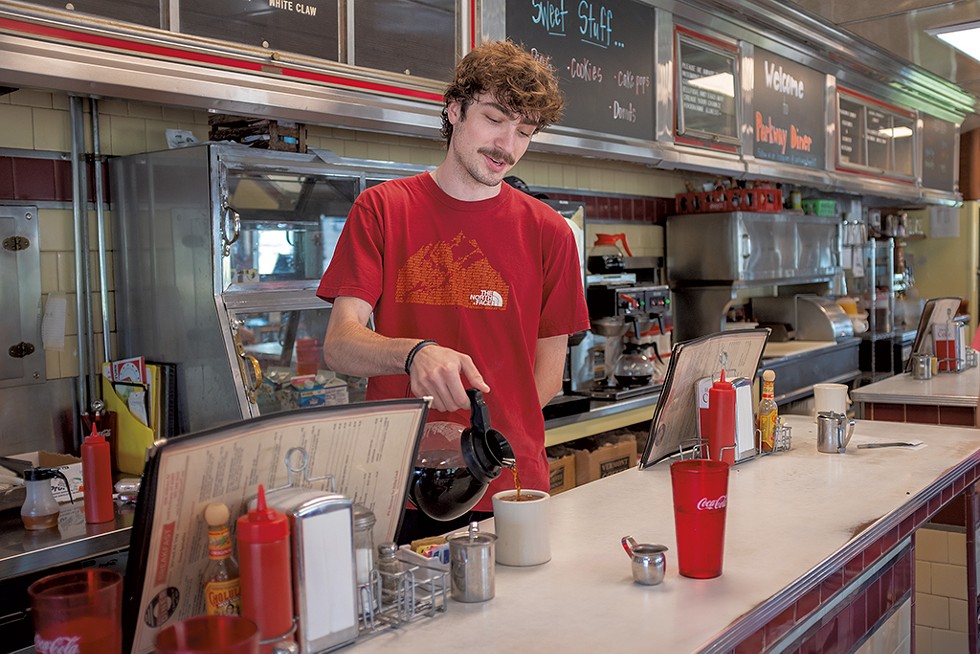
[{"xmin": 110, "ymin": 143, "xmax": 425, "ymax": 433}]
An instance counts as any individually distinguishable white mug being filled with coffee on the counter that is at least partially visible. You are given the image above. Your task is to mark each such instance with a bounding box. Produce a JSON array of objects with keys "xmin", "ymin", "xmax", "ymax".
[{"xmin": 491, "ymin": 490, "xmax": 551, "ymax": 566}]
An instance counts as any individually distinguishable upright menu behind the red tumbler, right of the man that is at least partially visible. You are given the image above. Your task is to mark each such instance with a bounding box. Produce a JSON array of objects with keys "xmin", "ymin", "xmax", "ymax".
[{"xmin": 639, "ymin": 327, "xmax": 771, "ymax": 470}]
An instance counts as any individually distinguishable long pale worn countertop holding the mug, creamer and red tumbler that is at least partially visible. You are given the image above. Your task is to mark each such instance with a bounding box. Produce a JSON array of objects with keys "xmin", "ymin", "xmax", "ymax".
[{"xmin": 353, "ymin": 416, "xmax": 980, "ymax": 654}]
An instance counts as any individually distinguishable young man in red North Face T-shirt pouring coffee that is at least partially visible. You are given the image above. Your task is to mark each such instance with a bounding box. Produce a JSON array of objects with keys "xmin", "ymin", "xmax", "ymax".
[{"xmin": 317, "ymin": 41, "xmax": 589, "ymax": 543}]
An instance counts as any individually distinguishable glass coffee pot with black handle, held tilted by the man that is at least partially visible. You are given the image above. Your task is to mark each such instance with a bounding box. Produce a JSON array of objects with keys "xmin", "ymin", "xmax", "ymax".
[{"xmin": 408, "ymin": 388, "xmax": 516, "ymax": 521}]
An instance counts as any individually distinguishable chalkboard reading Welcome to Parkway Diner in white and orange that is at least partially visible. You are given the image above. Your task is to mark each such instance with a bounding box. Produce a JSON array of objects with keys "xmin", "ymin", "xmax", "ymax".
[{"xmin": 752, "ymin": 48, "xmax": 827, "ymax": 168}]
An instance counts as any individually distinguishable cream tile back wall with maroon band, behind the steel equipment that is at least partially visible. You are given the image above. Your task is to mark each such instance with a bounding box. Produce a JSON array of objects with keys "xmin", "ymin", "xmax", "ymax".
[{"xmin": 0, "ymin": 89, "xmax": 684, "ymax": 380}]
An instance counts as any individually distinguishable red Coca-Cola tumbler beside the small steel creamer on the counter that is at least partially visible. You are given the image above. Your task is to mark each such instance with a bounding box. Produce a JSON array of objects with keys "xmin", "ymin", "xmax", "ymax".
[{"xmin": 670, "ymin": 459, "xmax": 729, "ymax": 579}]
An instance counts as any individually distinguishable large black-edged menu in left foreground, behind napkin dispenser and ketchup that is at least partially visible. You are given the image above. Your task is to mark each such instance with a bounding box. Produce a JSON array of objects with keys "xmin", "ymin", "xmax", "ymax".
[{"xmin": 123, "ymin": 398, "xmax": 429, "ymax": 654}]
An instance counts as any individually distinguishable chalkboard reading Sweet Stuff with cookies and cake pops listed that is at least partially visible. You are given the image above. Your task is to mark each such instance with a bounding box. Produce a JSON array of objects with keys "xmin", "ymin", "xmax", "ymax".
[{"xmin": 506, "ymin": 0, "xmax": 656, "ymax": 141}]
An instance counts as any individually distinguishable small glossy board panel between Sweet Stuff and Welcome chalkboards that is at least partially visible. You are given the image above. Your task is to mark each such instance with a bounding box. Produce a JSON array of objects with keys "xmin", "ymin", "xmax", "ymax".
[{"xmin": 677, "ymin": 29, "xmax": 739, "ymax": 144}]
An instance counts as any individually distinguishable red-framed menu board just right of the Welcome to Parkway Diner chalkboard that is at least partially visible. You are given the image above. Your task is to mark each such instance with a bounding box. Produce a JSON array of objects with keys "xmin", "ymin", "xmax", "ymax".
[{"xmin": 834, "ymin": 87, "xmax": 921, "ymax": 184}]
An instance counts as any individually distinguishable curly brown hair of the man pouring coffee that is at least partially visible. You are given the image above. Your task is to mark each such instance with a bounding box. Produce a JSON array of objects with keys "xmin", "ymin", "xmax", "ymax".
[{"xmin": 442, "ymin": 41, "xmax": 565, "ymax": 144}]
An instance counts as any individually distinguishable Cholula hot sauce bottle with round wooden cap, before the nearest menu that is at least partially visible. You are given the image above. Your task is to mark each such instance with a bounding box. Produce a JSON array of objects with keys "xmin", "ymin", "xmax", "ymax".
[{"xmin": 204, "ymin": 502, "xmax": 241, "ymax": 615}]
